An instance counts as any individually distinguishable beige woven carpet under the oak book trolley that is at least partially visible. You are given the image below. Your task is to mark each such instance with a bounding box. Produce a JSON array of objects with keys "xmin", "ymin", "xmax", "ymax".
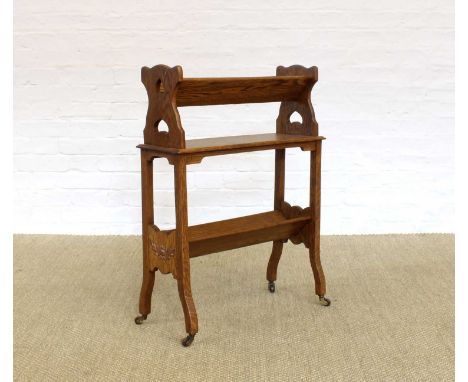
[{"xmin": 14, "ymin": 234, "xmax": 454, "ymax": 382}]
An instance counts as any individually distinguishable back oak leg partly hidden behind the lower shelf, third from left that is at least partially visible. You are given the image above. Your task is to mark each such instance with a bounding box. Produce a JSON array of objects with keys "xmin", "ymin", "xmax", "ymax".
[{"xmin": 267, "ymin": 149, "xmax": 286, "ymax": 293}]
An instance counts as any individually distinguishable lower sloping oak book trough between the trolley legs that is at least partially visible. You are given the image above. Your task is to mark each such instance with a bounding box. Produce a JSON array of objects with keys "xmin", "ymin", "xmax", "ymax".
[{"xmin": 153, "ymin": 211, "xmax": 311, "ymax": 257}]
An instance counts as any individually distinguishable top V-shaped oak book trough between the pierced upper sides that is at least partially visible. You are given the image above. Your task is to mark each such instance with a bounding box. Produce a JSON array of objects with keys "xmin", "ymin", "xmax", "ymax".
[{"xmin": 176, "ymin": 76, "xmax": 316, "ymax": 106}]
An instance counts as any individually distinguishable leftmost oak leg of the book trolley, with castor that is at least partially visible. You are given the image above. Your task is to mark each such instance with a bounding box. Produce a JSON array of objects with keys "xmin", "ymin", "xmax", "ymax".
[{"xmin": 135, "ymin": 150, "xmax": 155, "ymax": 325}]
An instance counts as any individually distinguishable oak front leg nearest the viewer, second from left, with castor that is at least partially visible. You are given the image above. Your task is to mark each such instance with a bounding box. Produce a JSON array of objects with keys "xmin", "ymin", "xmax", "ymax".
[{"xmin": 174, "ymin": 158, "xmax": 198, "ymax": 346}]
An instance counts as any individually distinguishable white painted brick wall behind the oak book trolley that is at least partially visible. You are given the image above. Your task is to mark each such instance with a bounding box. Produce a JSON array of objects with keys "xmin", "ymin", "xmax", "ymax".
[{"xmin": 14, "ymin": 0, "xmax": 454, "ymax": 234}]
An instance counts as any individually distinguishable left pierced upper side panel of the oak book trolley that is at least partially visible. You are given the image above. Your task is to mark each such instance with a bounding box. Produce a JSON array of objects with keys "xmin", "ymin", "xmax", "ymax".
[{"xmin": 141, "ymin": 65, "xmax": 185, "ymax": 148}]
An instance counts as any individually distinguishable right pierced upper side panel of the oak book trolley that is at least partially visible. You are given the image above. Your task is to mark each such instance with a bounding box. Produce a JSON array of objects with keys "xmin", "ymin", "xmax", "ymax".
[{"xmin": 276, "ymin": 65, "xmax": 318, "ymax": 136}]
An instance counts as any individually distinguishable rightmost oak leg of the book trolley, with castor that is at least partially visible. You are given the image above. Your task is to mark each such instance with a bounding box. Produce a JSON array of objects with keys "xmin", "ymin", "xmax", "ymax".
[{"xmin": 309, "ymin": 141, "xmax": 330, "ymax": 306}]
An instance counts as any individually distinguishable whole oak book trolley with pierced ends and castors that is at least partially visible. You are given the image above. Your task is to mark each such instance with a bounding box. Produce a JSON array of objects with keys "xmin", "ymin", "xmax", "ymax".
[{"xmin": 135, "ymin": 65, "xmax": 330, "ymax": 346}]
